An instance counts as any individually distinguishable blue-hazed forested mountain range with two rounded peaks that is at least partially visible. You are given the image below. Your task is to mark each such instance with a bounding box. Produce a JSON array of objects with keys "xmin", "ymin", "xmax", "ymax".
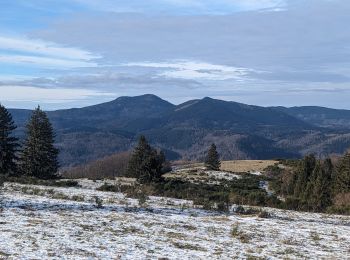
[{"xmin": 10, "ymin": 94, "xmax": 350, "ymax": 167}]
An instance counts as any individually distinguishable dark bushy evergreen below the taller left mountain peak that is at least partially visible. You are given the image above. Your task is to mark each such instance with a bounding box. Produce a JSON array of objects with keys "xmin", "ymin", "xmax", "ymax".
[{"xmin": 127, "ymin": 136, "xmax": 165, "ymax": 183}]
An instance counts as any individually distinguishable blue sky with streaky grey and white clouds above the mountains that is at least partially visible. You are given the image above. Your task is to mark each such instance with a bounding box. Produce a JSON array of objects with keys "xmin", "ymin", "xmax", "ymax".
[{"xmin": 0, "ymin": 0, "xmax": 350, "ymax": 110}]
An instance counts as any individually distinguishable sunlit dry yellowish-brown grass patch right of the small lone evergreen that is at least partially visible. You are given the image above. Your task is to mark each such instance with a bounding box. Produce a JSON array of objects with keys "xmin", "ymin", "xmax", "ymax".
[{"xmin": 221, "ymin": 160, "xmax": 278, "ymax": 172}]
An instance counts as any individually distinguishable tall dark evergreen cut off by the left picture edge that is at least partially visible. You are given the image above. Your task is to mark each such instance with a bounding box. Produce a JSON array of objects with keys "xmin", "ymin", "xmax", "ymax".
[{"xmin": 0, "ymin": 105, "xmax": 19, "ymax": 175}]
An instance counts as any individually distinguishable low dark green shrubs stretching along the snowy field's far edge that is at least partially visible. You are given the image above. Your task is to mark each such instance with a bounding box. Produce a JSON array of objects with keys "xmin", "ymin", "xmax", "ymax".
[{"xmin": 98, "ymin": 174, "xmax": 281, "ymax": 212}]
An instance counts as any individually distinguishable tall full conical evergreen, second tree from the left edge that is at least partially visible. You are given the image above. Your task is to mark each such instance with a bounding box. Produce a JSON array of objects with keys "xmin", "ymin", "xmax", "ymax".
[{"xmin": 21, "ymin": 107, "xmax": 59, "ymax": 179}]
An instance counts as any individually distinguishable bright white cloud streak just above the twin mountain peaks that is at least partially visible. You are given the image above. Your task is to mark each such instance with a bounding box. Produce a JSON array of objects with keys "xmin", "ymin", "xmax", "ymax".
[{"xmin": 126, "ymin": 61, "xmax": 253, "ymax": 80}]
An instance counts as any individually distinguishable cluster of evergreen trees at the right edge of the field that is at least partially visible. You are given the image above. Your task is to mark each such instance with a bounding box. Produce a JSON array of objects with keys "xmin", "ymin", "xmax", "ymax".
[{"xmin": 277, "ymin": 153, "xmax": 350, "ymax": 213}]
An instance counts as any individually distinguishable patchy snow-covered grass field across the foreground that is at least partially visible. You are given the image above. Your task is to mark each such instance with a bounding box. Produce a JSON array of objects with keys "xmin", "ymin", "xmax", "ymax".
[{"xmin": 0, "ymin": 183, "xmax": 350, "ymax": 259}]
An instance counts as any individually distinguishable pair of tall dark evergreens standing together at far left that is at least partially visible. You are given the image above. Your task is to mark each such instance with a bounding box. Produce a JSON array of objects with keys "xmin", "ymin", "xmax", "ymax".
[{"xmin": 0, "ymin": 105, "xmax": 59, "ymax": 179}]
